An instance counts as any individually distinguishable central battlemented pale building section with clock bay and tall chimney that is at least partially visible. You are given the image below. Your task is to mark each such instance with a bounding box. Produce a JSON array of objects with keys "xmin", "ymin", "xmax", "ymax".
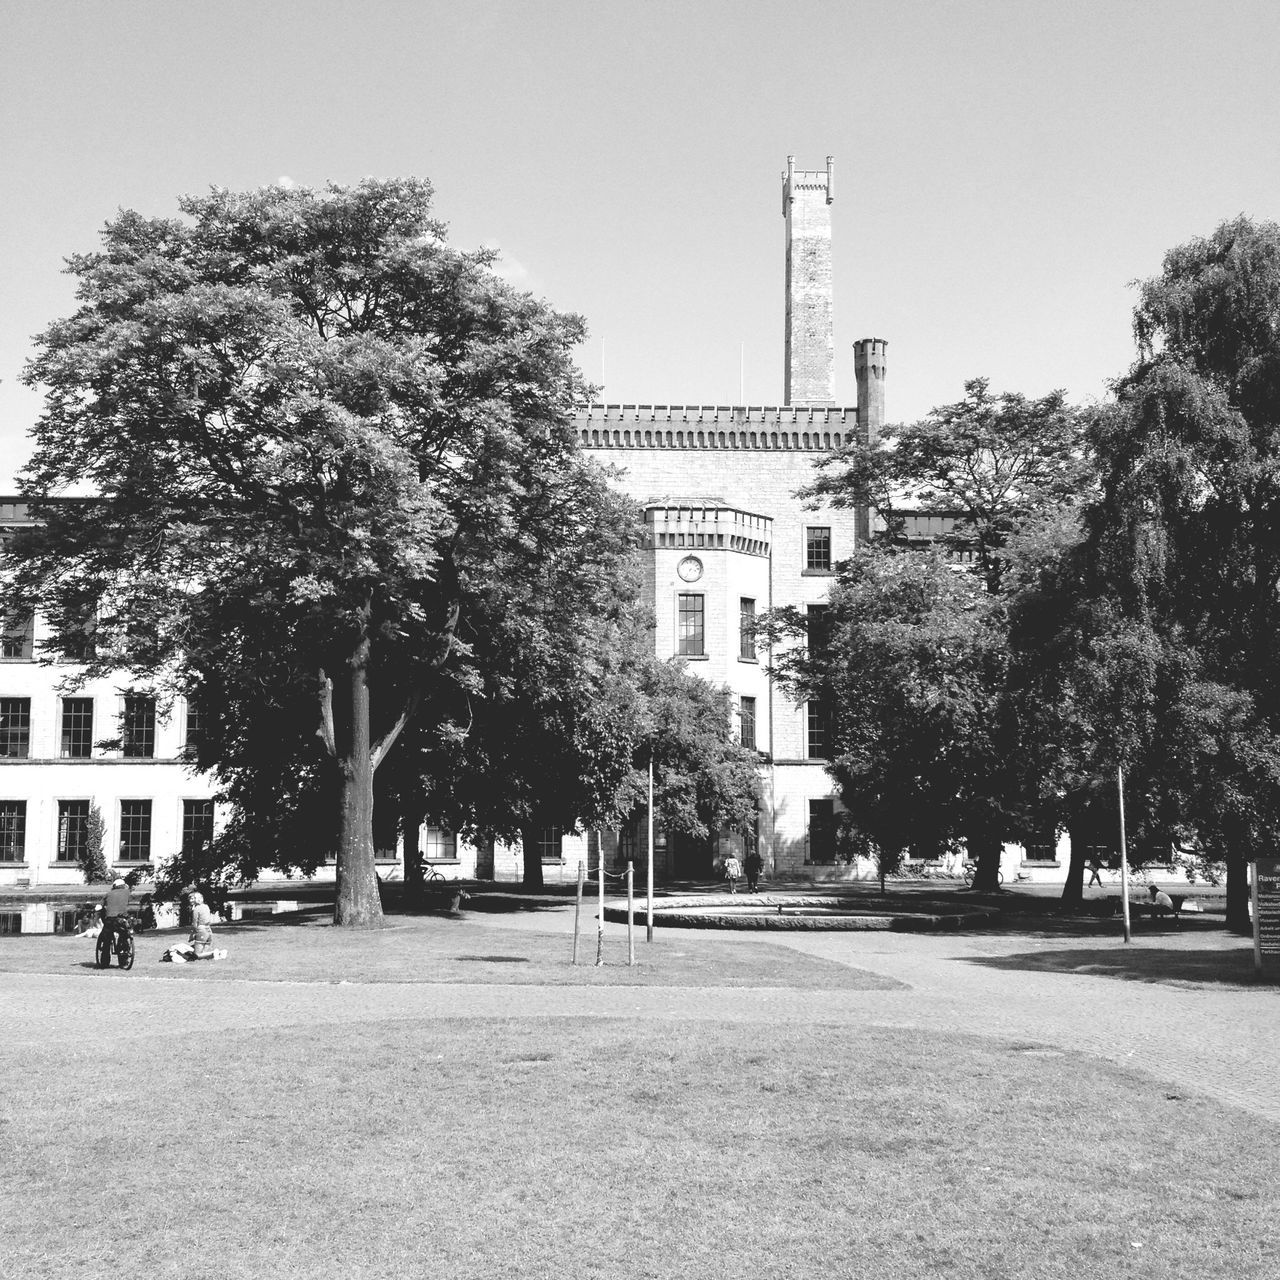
[{"xmin": 577, "ymin": 156, "xmax": 886, "ymax": 878}]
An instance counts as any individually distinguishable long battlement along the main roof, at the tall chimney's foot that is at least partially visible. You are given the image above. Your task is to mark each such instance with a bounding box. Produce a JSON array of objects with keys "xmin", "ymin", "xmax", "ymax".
[{"xmin": 573, "ymin": 404, "xmax": 858, "ymax": 453}]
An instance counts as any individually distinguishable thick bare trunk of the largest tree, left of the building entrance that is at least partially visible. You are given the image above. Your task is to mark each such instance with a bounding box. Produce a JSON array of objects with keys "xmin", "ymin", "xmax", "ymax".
[{"xmin": 333, "ymin": 637, "xmax": 383, "ymax": 929}]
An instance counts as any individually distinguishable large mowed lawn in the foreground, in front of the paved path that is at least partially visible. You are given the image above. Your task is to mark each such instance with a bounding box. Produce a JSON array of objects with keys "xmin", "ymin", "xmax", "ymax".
[{"xmin": 0, "ymin": 1008, "xmax": 1280, "ymax": 1280}]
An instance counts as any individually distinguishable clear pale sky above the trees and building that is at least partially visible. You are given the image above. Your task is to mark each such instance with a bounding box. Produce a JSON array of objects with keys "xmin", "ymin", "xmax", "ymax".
[{"xmin": 0, "ymin": 0, "xmax": 1280, "ymax": 492}]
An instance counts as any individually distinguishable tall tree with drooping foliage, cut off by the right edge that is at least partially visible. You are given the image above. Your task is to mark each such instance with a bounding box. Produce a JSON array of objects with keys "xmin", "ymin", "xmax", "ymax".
[{"xmin": 1088, "ymin": 218, "xmax": 1280, "ymax": 927}]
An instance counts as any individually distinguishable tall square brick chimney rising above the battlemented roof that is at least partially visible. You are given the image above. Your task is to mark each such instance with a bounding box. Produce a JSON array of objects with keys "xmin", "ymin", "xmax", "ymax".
[{"xmin": 782, "ymin": 156, "xmax": 836, "ymax": 404}]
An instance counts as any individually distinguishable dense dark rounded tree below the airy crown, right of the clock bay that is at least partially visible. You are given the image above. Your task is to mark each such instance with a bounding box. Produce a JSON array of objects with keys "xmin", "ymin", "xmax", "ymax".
[{"xmin": 765, "ymin": 548, "xmax": 1023, "ymax": 890}]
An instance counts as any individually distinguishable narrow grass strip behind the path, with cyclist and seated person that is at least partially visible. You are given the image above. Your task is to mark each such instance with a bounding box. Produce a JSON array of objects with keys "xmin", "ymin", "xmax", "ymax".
[{"xmin": 0, "ymin": 915, "xmax": 901, "ymax": 991}]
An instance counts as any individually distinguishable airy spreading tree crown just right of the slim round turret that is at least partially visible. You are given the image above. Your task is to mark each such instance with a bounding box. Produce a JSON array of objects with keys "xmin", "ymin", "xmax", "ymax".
[{"xmin": 806, "ymin": 378, "xmax": 1089, "ymax": 589}]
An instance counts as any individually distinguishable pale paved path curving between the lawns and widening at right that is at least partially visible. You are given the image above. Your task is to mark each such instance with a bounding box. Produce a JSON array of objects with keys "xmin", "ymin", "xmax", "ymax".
[{"xmin": 0, "ymin": 909, "xmax": 1280, "ymax": 1123}]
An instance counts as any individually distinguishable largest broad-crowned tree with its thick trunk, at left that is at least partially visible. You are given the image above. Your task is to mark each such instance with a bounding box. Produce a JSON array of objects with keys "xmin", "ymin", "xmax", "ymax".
[{"xmin": 13, "ymin": 179, "xmax": 595, "ymax": 925}]
